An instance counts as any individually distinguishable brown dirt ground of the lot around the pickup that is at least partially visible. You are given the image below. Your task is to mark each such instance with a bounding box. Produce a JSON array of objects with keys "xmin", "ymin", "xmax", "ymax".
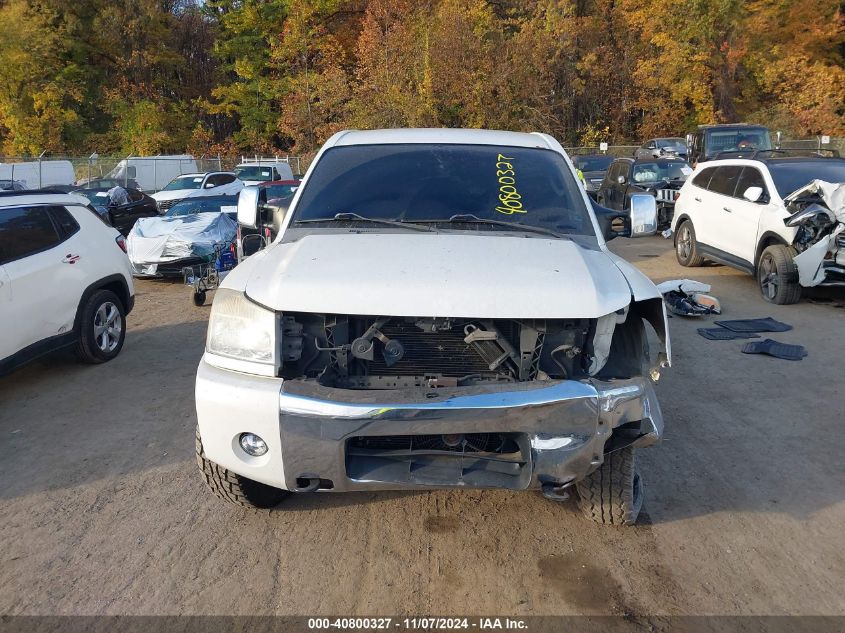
[{"xmin": 0, "ymin": 237, "xmax": 845, "ymax": 615}]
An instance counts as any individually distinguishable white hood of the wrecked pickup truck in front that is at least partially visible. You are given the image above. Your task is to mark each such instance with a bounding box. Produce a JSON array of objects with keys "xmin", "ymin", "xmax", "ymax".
[{"xmin": 239, "ymin": 233, "xmax": 631, "ymax": 319}]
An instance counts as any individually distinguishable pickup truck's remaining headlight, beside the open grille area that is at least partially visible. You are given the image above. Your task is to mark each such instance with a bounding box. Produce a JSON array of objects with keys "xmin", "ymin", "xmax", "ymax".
[{"xmin": 205, "ymin": 288, "xmax": 277, "ymax": 367}]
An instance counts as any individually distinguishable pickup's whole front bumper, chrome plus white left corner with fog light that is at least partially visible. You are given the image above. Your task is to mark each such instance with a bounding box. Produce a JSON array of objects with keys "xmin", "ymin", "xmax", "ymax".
[{"xmin": 196, "ymin": 360, "xmax": 663, "ymax": 492}]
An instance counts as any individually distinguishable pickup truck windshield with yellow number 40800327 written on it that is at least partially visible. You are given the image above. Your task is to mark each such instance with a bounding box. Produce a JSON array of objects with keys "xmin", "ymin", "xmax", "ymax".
[{"xmin": 292, "ymin": 143, "xmax": 595, "ymax": 236}]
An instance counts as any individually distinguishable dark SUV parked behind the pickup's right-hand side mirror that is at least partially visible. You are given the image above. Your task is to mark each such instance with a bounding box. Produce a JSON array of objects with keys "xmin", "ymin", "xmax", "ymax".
[{"xmin": 596, "ymin": 158, "xmax": 692, "ymax": 229}]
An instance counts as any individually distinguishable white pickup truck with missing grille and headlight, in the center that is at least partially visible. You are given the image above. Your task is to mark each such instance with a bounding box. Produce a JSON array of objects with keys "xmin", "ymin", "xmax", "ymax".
[{"xmin": 196, "ymin": 130, "xmax": 670, "ymax": 524}]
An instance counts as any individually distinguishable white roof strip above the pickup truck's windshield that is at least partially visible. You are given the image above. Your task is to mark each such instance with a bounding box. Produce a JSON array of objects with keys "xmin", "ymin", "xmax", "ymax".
[{"xmin": 332, "ymin": 128, "xmax": 555, "ymax": 149}]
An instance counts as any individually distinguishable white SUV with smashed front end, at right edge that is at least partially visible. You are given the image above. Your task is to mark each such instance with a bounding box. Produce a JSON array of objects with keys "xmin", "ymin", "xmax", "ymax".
[{"xmin": 672, "ymin": 152, "xmax": 845, "ymax": 304}]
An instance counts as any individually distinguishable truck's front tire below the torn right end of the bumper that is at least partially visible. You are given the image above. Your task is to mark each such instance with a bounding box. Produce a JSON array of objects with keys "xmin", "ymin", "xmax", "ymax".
[{"xmin": 575, "ymin": 446, "xmax": 643, "ymax": 525}]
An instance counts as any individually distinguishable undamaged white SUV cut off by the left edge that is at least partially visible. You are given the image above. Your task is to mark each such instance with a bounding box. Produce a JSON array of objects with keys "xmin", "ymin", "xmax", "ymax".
[{"xmin": 0, "ymin": 191, "xmax": 135, "ymax": 374}]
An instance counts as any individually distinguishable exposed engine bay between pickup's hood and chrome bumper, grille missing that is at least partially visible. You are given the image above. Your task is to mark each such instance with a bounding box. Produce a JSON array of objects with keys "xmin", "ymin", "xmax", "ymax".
[{"xmin": 280, "ymin": 314, "xmax": 596, "ymax": 389}]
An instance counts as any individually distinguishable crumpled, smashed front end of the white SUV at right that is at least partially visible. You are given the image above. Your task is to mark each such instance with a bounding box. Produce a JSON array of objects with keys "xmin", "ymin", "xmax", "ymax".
[{"xmin": 784, "ymin": 180, "xmax": 845, "ymax": 287}]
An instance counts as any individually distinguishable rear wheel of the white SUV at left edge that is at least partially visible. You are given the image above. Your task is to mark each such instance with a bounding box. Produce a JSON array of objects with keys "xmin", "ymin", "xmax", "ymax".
[{"xmin": 76, "ymin": 290, "xmax": 126, "ymax": 364}]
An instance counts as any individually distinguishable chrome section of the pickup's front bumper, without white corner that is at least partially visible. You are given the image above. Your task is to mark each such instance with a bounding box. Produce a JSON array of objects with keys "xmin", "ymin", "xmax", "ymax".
[{"xmin": 274, "ymin": 379, "xmax": 663, "ymax": 491}]
